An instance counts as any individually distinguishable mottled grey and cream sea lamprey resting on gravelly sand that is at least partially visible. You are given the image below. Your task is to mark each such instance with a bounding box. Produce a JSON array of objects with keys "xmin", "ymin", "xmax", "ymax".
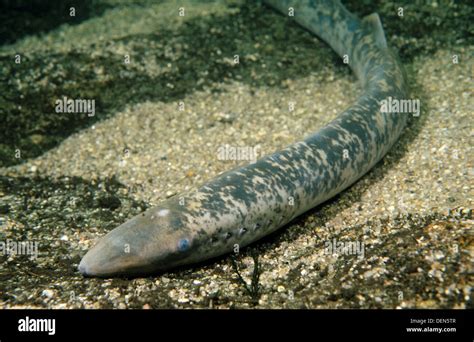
[{"xmin": 79, "ymin": 0, "xmax": 407, "ymax": 277}]
